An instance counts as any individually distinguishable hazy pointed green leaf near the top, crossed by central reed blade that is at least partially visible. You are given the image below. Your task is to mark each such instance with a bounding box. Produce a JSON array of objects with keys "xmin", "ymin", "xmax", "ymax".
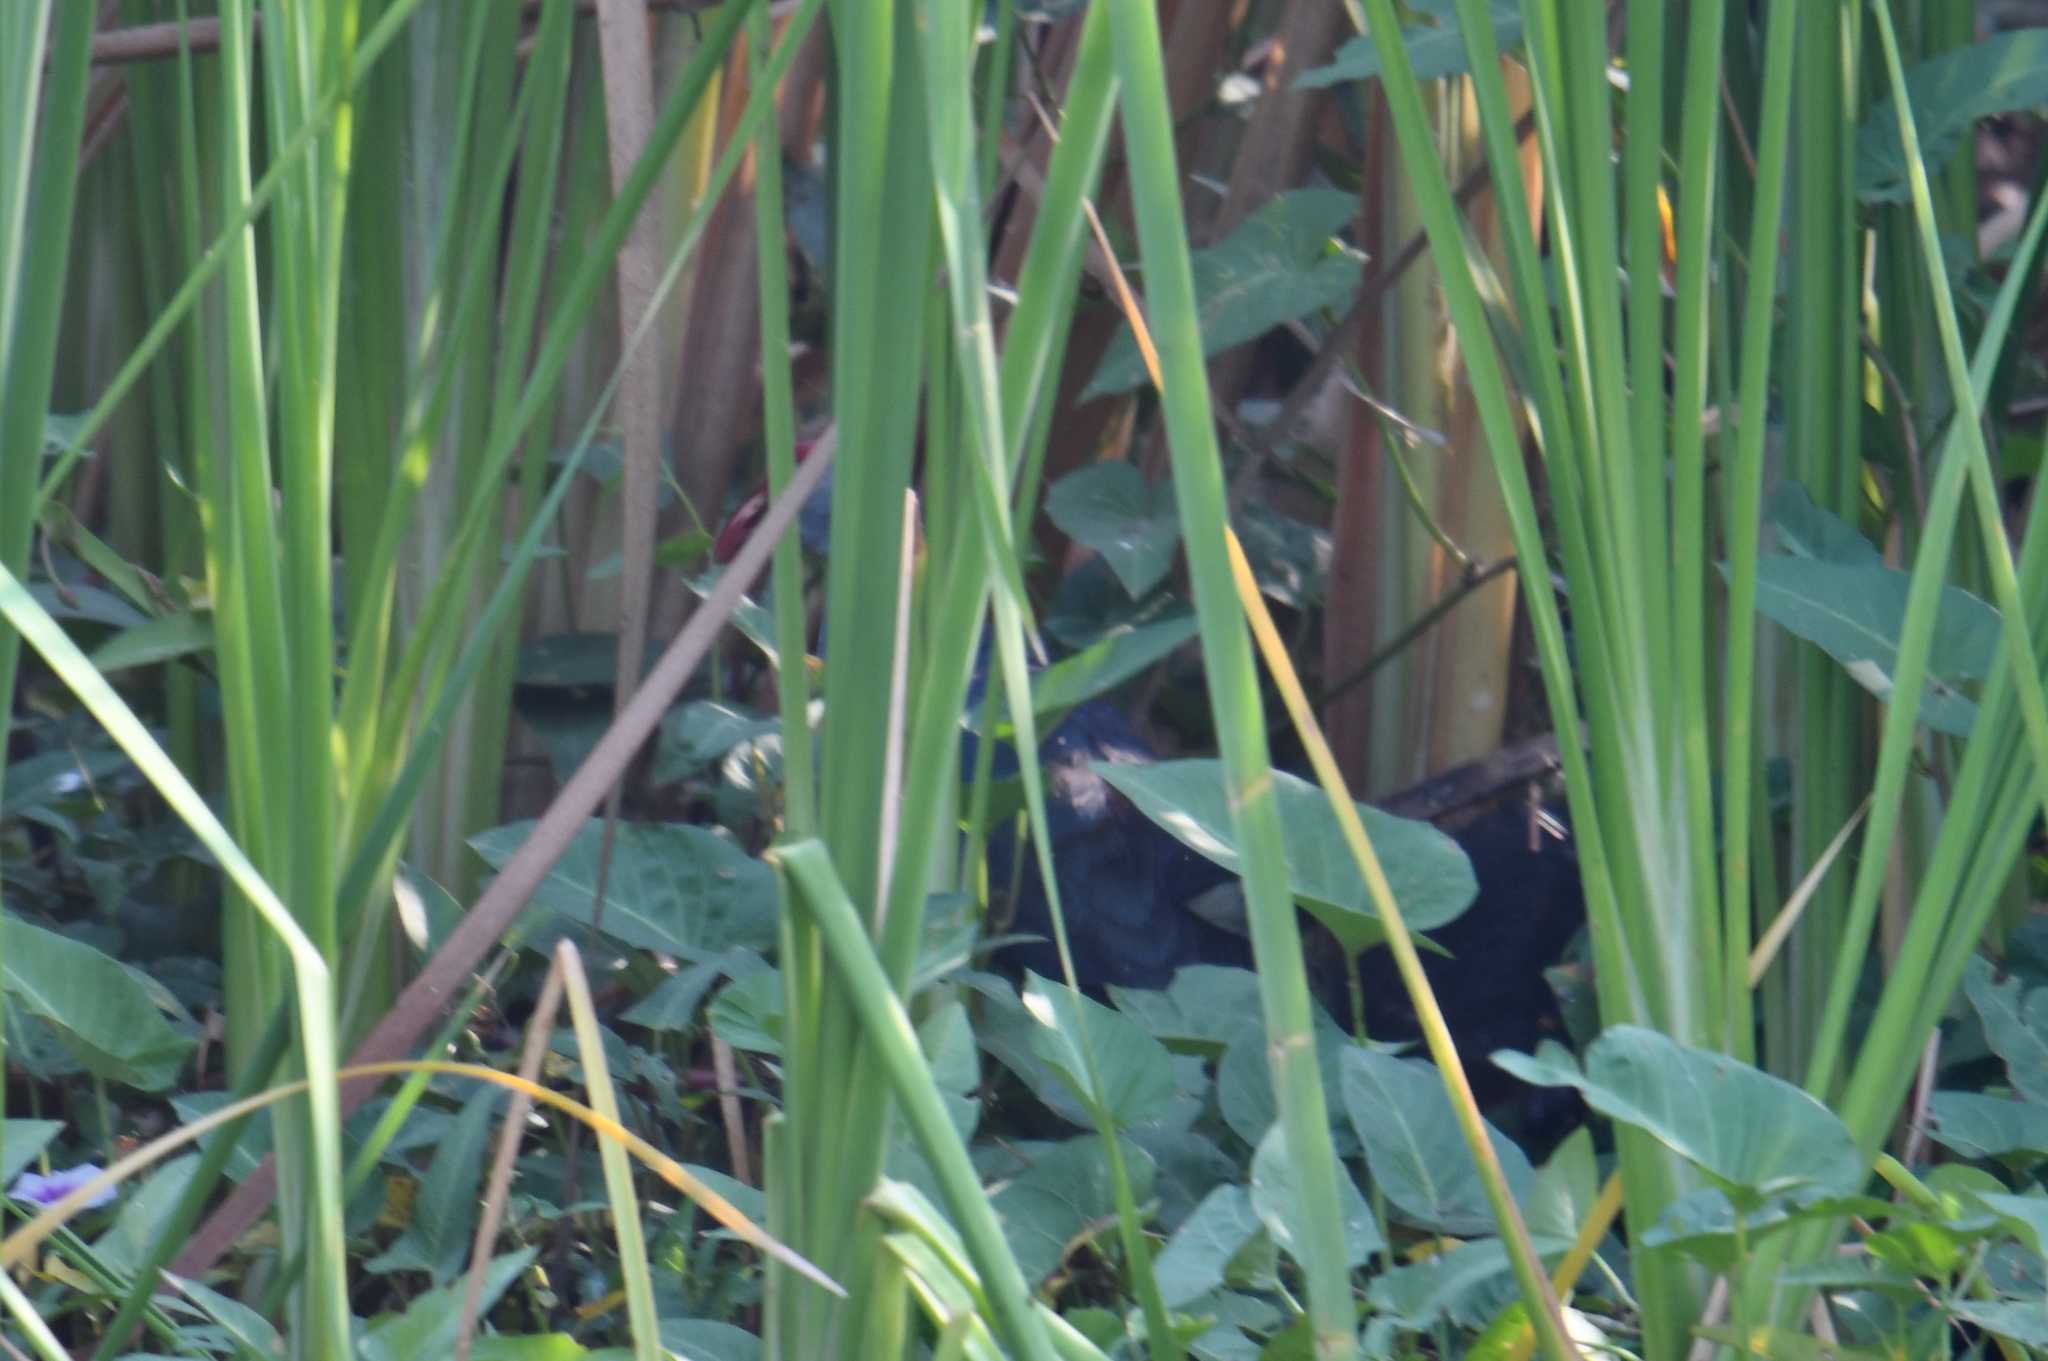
[{"xmin": 1089, "ymin": 188, "xmax": 1364, "ymax": 399}]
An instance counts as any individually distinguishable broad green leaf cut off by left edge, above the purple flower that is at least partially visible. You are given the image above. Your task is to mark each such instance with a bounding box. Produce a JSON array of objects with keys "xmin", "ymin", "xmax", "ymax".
[{"xmin": 0, "ymin": 915, "xmax": 193, "ymax": 1091}]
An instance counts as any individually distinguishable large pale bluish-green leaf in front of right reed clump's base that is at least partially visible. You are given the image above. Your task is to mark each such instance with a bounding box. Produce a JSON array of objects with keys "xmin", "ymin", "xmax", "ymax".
[{"xmin": 1493, "ymin": 1025, "xmax": 1866, "ymax": 1203}]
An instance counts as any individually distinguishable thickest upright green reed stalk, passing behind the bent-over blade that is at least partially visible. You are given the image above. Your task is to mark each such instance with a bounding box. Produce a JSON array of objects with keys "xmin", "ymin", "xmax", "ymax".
[{"xmin": 776, "ymin": 0, "xmax": 942, "ymax": 1357}]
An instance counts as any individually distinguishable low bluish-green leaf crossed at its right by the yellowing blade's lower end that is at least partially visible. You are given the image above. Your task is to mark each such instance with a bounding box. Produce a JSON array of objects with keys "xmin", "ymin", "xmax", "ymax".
[{"xmin": 1341, "ymin": 1046, "xmax": 1536, "ymax": 1238}]
